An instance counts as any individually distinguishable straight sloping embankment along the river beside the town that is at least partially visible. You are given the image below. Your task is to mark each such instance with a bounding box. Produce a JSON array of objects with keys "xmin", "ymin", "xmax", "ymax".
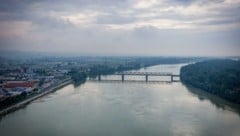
[{"xmin": 0, "ymin": 79, "xmax": 72, "ymax": 117}]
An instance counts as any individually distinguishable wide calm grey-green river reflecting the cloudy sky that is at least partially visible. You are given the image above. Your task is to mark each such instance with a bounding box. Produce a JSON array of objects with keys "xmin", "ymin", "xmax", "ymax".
[{"xmin": 0, "ymin": 64, "xmax": 240, "ymax": 136}]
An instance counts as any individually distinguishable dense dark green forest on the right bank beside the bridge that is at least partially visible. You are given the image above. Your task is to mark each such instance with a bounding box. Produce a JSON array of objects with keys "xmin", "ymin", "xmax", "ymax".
[{"xmin": 180, "ymin": 59, "xmax": 240, "ymax": 104}]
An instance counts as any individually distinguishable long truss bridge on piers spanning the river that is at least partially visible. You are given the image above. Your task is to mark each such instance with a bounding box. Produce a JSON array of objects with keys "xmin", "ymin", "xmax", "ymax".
[{"xmin": 98, "ymin": 72, "xmax": 180, "ymax": 82}]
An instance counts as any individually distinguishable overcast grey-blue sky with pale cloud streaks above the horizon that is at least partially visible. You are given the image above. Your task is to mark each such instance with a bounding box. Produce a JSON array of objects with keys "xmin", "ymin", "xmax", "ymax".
[{"xmin": 0, "ymin": 0, "xmax": 240, "ymax": 56}]
